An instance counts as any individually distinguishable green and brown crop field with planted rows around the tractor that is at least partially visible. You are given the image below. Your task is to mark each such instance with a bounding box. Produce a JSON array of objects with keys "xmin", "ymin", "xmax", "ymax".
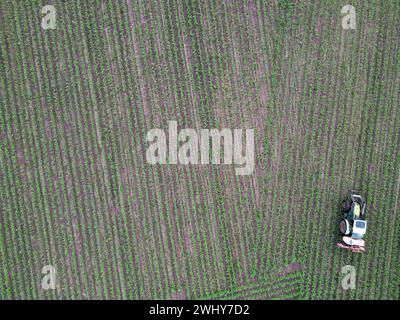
[{"xmin": 0, "ymin": 0, "xmax": 400, "ymax": 300}]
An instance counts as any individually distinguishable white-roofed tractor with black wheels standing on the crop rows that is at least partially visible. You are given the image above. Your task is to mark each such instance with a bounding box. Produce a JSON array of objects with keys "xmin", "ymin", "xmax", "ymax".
[{"xmin": 337, "ymin": 190, "xmax": 367, "ymax": 252}]
